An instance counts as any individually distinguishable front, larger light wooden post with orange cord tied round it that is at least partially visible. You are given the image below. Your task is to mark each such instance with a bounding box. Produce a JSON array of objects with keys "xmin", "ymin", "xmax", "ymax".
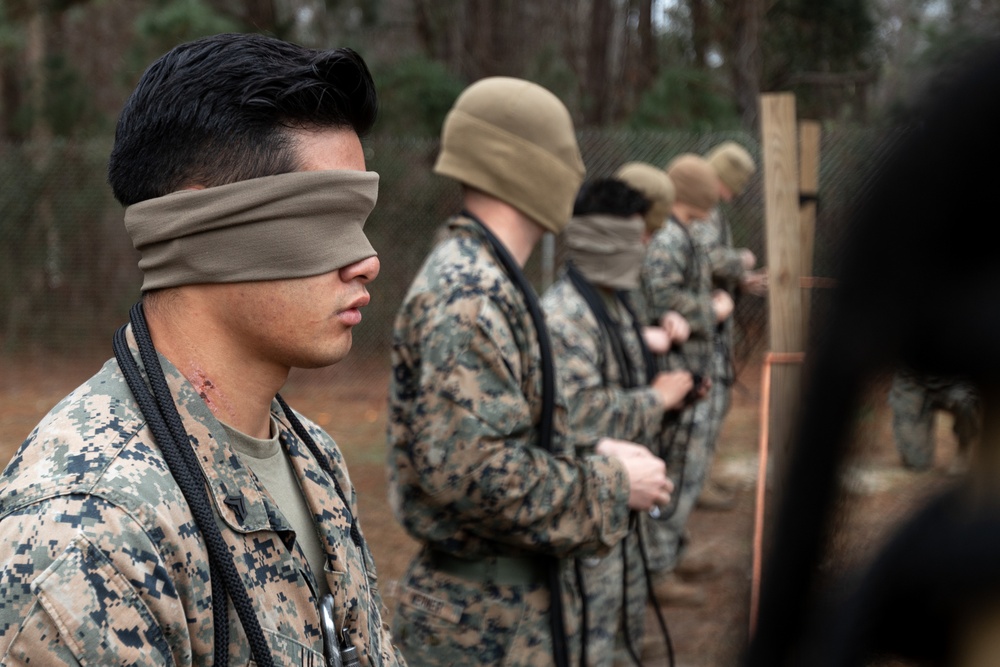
[{"xmin": 760, "ymin": 93, "xmax": 803, "ymax": 502}]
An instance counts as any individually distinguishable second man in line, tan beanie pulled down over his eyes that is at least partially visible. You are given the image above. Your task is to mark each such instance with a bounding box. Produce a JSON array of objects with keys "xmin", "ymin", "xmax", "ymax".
[{"xmin": 389, "ymin": 77, "xmax": 672, "ymax": 666}]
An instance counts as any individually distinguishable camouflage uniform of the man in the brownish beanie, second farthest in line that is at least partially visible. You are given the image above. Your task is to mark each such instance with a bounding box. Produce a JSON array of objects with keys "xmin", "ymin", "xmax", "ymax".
[{"xmin": 642, "ymin": 218, "xmax": 715, "ymax": 572}]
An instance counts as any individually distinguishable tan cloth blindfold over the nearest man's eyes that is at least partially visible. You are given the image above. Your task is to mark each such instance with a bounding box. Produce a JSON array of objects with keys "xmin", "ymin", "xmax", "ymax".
[{"xmin": 125, "ymin": 171, "xmax": 378, "ymax": 291}]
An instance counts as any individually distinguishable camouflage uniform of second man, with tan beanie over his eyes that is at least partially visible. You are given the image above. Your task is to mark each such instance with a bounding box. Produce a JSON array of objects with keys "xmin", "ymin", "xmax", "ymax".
[{"xmin": 388, "ymin": 217, "xmax": 629, "ymax": 666}]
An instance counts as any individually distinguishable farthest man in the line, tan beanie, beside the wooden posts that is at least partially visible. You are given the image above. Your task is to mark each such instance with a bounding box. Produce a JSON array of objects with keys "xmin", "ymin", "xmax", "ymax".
[{"xmin": 691, "ymin": 141, "xmax": 767, "ymax": 510}]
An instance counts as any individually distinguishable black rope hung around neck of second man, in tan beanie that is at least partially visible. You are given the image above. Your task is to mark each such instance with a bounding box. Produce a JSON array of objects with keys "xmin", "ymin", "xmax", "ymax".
[{"xmin": 462, "ymin": 211, "xmax": 569, "ymax": 667}]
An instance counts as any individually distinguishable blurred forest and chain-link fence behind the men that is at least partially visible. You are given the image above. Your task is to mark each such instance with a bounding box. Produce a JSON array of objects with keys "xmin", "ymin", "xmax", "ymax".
[{"xmin": 0, "ymin": 0, "xmax": 1000, "ymax": 366}]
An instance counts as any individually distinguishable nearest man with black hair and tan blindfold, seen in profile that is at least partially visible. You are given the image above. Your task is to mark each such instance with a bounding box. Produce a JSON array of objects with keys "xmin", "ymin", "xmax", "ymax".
[{"xmin": 0, "ymin": 35, "xmax": 402, "ymax": 667}]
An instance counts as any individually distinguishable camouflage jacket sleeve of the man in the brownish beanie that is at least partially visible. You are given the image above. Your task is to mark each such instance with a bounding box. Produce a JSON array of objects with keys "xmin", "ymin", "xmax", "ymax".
[{"xmin": 641, "ymin": 223, "xmax": 711, "ymax": 338}]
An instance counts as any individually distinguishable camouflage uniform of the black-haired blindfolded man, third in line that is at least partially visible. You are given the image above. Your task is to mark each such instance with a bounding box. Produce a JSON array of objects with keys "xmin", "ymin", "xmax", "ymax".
[{"xmin": 542, "ymin": 276, "xmax": 664, "ymax": 666}]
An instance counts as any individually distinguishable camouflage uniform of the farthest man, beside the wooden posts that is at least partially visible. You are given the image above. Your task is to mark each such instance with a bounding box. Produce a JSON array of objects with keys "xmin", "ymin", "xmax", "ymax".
[{"xmin": 690, "ymin": 207, "xmax": 746, "ymax": 464}]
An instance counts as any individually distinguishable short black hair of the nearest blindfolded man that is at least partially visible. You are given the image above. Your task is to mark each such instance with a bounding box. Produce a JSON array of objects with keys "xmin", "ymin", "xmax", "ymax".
[{"xmin": 108, "ymin": 33, "xmax": 378, "ymax": 206}]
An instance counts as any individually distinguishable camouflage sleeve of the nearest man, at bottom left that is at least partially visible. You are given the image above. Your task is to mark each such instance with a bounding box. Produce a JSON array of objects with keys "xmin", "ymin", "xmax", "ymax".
[{"xmin": 0, "ymin": 496, "xmax": 178, "ymax": 667}]
